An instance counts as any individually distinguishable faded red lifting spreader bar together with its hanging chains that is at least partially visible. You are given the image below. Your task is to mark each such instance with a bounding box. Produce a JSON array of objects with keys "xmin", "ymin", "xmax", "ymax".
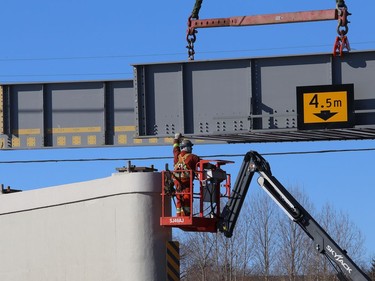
[{"xmin": 186, "ymin": 0, "xmax": 351, "ymax": 60}]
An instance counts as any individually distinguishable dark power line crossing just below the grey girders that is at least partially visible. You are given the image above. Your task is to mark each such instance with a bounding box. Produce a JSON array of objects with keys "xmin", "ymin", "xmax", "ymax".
[{"xmin": 0, "ymin": 148, "xmax": 375, "ymax": 164}]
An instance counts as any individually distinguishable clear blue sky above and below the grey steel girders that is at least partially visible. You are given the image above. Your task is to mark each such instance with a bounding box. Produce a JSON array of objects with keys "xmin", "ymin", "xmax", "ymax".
[{"xmin": 0, "ymin": 0, "xmax": 375, "ymax": 257}]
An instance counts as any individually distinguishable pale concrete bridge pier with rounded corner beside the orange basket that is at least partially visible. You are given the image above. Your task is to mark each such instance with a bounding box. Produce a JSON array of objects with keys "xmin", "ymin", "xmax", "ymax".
[{"xmin": 0, "ymin": 172, "xmax": 171, "ymax": 281}]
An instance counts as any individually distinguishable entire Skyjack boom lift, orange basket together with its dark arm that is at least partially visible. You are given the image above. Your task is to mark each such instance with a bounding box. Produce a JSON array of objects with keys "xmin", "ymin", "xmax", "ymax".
[{"xmin": 160, "ymin": 151, "xmax": 371, "ymax": 281}]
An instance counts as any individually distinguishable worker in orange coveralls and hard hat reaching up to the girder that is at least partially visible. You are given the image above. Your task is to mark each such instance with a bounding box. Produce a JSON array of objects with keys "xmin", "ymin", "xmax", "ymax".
[{"xmin": 173, "ymin": 133, "xmax": 200, "ymax": 217}]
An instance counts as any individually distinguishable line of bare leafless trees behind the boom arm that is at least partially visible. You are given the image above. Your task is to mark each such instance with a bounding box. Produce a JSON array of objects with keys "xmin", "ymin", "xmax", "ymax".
[{"xmin": 177, "ymin": 188, "xmax": 375, "ymax": 281}]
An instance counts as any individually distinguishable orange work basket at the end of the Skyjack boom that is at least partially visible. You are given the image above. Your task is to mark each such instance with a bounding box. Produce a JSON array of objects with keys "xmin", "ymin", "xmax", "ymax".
[{"xmin": 160, "ymin": 160, "xmax": 233, "ymax": 232}]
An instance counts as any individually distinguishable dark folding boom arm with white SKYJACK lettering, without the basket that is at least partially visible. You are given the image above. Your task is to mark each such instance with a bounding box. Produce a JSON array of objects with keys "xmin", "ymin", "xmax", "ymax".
[{"xmin": 218, "ymin": 151, "xmax": 371, "ymax": 281}]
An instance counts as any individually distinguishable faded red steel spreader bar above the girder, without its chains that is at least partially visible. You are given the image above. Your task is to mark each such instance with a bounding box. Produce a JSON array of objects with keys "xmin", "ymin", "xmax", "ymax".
[{"xmin": 189, "ymin": 9, "xmax": 338, "ymax": 30}]
